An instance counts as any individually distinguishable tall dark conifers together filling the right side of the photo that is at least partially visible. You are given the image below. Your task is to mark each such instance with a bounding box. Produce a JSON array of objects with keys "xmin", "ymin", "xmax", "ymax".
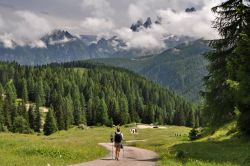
[{"xmin": 203, "ymin": 0, "xmax": 250, "ymax": 135}]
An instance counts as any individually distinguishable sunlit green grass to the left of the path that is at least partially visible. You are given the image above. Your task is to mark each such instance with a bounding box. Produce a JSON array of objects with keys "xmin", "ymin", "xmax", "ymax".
[{"xmin": 0, "ymin": 128, "xmax": 110, "ymax": 166}]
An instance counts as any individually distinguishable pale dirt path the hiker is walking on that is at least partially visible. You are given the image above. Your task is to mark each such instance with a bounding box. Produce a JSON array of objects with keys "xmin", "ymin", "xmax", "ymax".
[{"xmin": 70, "ymin": 143, "xmax": 158, "ymax": 166}]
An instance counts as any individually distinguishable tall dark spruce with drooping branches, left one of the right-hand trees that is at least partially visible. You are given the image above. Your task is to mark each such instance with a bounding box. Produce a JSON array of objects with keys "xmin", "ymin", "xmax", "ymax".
[{"xmin": 203, "ymin": 0, "xmax": 246, "ymax": 125}]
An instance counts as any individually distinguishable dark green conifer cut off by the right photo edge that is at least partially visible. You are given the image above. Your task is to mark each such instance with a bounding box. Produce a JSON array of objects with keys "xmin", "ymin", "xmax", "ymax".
[{"xmin": 236, "ymin": 13, "xmax": 250, "ymax": 135}]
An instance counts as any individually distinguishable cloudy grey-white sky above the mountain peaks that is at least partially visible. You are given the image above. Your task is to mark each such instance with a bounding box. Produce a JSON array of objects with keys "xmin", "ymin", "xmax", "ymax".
[{"xmin": 0, "ymin": 0, "xmax": 223, "ymax": 49}]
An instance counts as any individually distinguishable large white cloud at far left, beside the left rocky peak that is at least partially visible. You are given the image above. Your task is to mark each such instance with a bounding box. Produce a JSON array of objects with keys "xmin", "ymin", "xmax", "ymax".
[{"xmin": 0, "ymin": 11, "xmax": 52, "ymax": 48}]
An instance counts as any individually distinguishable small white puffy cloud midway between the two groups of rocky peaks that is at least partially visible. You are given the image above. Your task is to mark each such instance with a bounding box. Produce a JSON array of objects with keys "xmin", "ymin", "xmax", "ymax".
[{"xmin": 81, "ymin": 17, "xmax": 115, "ymax": 35}]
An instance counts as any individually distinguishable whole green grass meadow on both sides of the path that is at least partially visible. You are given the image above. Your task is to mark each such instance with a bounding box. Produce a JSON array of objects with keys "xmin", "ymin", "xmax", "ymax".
[{"xmin": 0, "ymin": 124, "xmax": 250, "ymax": 166}]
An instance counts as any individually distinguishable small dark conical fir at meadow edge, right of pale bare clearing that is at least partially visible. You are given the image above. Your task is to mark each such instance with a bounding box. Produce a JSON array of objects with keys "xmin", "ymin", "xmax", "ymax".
[{"xmin": 43, "ymin": 109, "xmax": 58, "ymax": 135}]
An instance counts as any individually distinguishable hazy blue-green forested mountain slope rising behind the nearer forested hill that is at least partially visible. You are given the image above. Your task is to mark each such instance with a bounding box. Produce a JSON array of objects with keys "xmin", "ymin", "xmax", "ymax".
[{"xmin": 91, "ymin": 40, "xmax": 210, "ymax": 101}]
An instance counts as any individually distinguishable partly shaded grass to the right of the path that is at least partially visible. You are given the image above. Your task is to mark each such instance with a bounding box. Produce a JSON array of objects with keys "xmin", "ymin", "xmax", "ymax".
[{"xmin": 125, "ymin": 122, "xmax": 250, "ymax": 166}]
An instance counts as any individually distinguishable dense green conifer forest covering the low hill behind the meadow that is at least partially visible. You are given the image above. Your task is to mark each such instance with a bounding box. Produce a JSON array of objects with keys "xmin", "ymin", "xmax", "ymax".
[{"xmin": 0, "ymin": 62, "xmax": 201, "ymax": 135}]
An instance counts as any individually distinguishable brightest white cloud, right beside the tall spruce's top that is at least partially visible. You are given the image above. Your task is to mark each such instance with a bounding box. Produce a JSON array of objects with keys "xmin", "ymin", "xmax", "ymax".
[{"xmin": 157, "ymin": 2, "xmax": 219, "ymax": 39}]
